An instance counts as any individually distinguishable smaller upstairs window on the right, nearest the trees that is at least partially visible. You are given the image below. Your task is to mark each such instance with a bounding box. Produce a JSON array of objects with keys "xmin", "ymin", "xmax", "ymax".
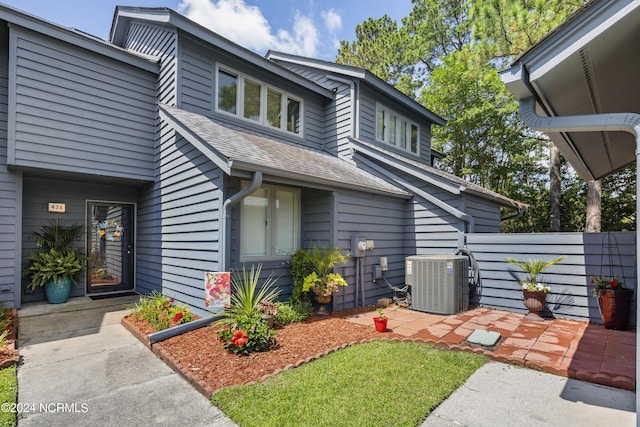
[{"xmin": 376, "ymin": 104, "xmax": 420, "ymax": 154}]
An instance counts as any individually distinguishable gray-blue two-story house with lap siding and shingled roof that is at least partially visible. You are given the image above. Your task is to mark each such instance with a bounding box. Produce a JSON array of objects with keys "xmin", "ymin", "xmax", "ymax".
[{"xmin": 0, "ymin": 6, "xmax": 521, "ymax": 314}]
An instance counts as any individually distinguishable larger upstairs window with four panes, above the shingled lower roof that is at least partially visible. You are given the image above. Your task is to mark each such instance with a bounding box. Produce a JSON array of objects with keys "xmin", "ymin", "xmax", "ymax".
[{"xmin": 216, "ymin": 67, "xmax": 302, "ymax": 135}]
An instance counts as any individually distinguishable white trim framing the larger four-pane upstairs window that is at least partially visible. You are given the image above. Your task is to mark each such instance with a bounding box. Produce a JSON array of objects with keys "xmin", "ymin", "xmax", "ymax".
[{"xmin": 214, "ymin": 64, "xmax": 304, "ymax": 138}]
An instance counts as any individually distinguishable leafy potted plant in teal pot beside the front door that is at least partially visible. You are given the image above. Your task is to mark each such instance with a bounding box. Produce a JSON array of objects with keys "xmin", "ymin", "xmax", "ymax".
[{"xmin": 23, "ymin": 220, "xmax": 86, "ymax": 304}]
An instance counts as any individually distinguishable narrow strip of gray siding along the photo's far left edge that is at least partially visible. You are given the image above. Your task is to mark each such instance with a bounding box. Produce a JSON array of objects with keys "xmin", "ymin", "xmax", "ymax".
[{"xmin": 0, "ymin": 25, "xmax": 22, "ymax": 307}]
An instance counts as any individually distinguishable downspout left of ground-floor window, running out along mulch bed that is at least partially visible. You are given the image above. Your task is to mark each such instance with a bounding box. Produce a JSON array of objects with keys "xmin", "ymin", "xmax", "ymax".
[{"xmin": 149, "ymin": 171, "xmax": 262, "ymax": 345}]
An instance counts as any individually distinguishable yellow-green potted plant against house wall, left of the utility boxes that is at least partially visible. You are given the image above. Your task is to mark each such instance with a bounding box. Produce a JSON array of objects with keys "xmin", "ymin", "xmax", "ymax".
[{"xmin": 302, "ymin": 247, "xmax": 349, "ymax": 316}]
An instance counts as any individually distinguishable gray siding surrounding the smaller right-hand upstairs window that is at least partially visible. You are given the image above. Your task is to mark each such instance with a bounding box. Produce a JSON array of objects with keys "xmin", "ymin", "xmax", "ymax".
[{"xmin": 359, "ymin": 84, "xmax": 431, "ymax": 165}]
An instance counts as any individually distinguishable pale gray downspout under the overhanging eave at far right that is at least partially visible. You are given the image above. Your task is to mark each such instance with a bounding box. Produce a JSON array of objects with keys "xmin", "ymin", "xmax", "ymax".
[{"xmin": 520, "ymin": 98, "xmax": 640, "ymax": 412}]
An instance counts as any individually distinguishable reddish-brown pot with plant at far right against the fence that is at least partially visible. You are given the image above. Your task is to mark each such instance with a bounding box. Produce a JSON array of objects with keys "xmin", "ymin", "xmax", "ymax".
[{"xmin": 591, "ymin": 276, "xmax": 633, "ymax": 331}]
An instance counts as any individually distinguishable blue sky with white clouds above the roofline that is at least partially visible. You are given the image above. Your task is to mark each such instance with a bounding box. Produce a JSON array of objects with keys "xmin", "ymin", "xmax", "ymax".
[{"xmin": 0, "ymin": 0, "xmax": 412, "ymax": 60}]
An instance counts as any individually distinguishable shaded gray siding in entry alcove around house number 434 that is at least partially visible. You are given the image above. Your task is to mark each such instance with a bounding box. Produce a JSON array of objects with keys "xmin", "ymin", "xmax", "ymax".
[{"xmin": 20, "ymin": 176, "xmax": 138, "ymax": 302}]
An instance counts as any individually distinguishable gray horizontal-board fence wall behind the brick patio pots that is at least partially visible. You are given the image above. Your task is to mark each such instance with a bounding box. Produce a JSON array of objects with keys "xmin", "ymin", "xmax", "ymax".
[{"xmin": 465, "ymin": 232, "xmax": 637, "ymax": 323}]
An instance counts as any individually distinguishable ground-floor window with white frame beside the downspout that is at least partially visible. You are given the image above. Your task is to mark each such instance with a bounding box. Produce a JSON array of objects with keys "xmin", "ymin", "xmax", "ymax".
[{"xmin": 240, "ymin": 183, "xmax": 300, "ymax": 260}]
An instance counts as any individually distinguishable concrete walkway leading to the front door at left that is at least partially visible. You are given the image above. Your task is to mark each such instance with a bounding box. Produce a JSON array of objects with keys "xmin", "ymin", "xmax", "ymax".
[{"xmin": 18, "ymin": 297, "xmax": 235, "ymax": 427}]
